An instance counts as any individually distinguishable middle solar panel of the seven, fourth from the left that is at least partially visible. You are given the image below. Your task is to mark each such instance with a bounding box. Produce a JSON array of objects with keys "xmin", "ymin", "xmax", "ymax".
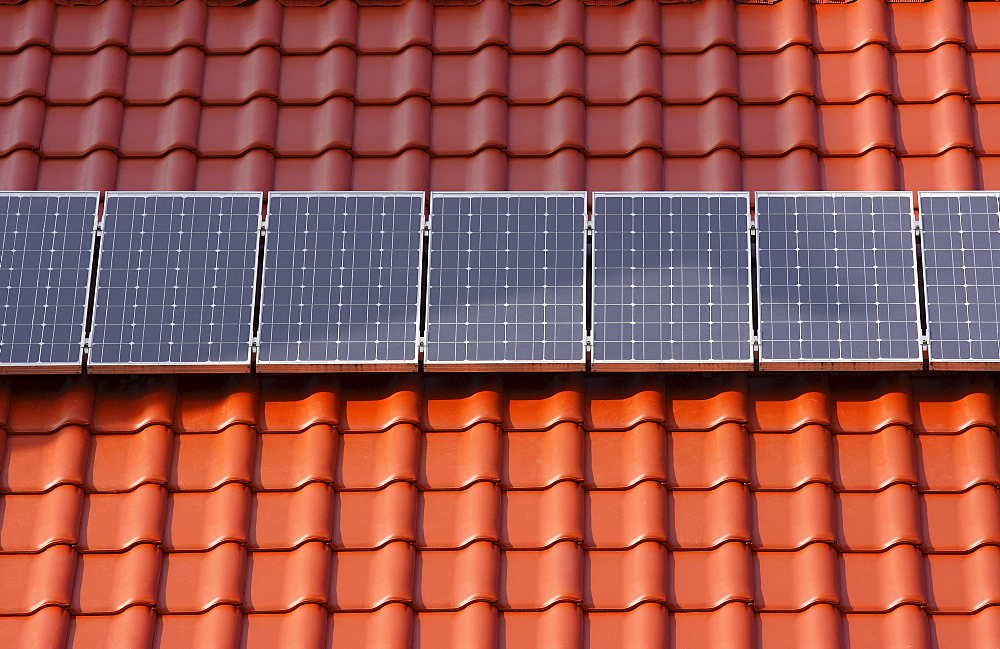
[{"xmin": 424, "ymin": 192, "xmax": 587, "ymax": 370}]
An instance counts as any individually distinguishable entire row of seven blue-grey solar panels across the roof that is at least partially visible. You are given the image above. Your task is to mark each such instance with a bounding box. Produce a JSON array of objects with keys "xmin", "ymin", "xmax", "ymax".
[{"xmin": 0, "ymin": 192, "xmax": 1000, "ymax": 372}]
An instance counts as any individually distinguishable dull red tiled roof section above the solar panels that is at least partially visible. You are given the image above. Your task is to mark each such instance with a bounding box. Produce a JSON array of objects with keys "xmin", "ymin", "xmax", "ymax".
[{"xmin": 0, "ymin": 0, "xmax": 1000, "ymax": 191}]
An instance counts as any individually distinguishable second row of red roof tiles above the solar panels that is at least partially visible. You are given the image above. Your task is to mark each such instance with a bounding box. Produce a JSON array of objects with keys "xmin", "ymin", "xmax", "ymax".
[{"xmin": 0, "ymin": 95, "xmax": 1000, "ymax": 158}]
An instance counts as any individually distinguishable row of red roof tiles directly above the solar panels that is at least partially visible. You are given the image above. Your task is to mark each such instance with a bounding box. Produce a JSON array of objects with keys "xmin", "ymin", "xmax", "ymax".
[{"xmin": 7, "ymin": 148, "xmax": 1000, "ymax": 193}]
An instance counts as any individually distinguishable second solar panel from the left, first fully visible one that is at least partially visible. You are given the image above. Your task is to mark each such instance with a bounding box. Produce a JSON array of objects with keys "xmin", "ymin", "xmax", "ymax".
[{"xmin": 88, "ymin": 192, "xmax": 261, "ymax": 372}]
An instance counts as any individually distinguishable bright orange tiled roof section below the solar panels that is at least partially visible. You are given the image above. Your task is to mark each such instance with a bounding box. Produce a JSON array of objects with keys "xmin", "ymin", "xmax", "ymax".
[{"xmin": 0, "ymin": 373, "xmax": 1000, "ymax": 649}]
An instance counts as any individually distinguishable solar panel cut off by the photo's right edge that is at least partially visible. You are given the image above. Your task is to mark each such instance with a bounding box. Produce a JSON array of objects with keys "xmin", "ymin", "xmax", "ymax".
[{"xmin": 920, "ymin": 192, "xmax": 1000, "ymax": 369}]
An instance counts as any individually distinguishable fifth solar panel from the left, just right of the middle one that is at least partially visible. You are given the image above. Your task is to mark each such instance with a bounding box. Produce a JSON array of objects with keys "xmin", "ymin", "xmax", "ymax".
[{"xmin": 592, "ymin": 193, "xmax": 753, "ymax": 370}]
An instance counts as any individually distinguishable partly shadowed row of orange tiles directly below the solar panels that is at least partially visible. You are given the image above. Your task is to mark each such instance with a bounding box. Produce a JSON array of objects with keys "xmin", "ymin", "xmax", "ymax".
[{"xmin": 0, "ymin": 372, "xmax": 1000, "ymax": 434}]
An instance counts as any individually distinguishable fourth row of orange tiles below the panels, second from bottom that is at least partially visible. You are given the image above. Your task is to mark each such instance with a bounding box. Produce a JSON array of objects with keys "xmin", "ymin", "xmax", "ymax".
[{"xmin": 9, "ymin": 542, "xmax": 1000, "ymax": 615}]
